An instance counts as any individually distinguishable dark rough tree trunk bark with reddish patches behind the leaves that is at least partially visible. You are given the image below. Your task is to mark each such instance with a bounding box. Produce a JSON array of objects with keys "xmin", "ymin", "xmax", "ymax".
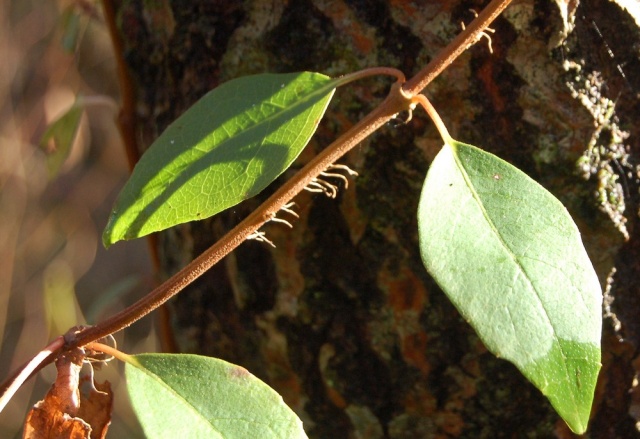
[{"xmin": 112, "ymin": 0, "xmax": 640, "ymax": 439}]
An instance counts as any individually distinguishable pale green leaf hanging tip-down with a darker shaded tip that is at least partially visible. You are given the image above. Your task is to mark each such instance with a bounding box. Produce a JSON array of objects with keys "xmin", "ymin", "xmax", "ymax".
[{"xmin": 418, "ymin": 140, "xmax": 602, "ymax": 433}]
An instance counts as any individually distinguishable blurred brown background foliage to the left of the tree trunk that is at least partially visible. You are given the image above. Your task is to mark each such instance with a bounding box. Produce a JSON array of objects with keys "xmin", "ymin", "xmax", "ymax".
[{"xmin": 0, "ymin": 0, "xmax": 158, "ymax": 438}]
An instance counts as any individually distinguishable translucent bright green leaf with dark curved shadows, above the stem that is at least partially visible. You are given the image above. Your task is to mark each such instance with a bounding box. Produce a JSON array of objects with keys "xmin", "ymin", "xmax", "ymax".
[{"xmin": 103, "ymin": 72, "xmax": 337, "ymax": 246}]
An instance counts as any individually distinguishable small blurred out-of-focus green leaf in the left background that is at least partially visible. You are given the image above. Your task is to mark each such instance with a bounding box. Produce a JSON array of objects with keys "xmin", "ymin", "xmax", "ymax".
[{"xmin": 40, "ymin": 103, "xmax": 82, "ymax": 178}]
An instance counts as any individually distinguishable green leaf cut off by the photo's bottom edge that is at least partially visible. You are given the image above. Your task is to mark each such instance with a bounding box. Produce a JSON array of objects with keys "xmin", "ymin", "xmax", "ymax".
[{"xmin": 125, "ymin": 354, "xmax": 307, "ymax": 439}]
